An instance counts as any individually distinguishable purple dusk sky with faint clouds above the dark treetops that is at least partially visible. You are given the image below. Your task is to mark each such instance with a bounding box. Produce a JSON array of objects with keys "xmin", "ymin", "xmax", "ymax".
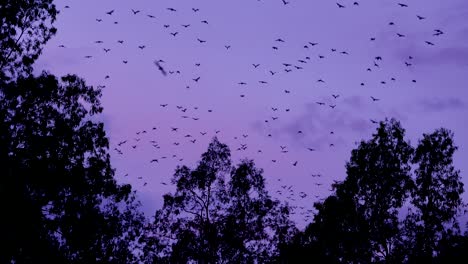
[{"xmin": 36, "ymin": 0, "xmax": 468, "ymax": 226}]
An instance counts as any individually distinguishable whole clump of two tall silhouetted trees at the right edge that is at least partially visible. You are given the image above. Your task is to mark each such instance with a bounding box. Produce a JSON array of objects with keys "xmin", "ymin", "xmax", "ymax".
[{"xmin": 282, "ymin": 119, "xmax": 468, "ymax": 263}]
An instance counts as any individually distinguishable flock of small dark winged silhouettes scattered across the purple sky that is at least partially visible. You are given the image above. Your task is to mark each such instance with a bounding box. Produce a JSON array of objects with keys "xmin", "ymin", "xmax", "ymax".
[{"xmin": 59, "ymin": 0, "xmax": 444, "ymax": 221}]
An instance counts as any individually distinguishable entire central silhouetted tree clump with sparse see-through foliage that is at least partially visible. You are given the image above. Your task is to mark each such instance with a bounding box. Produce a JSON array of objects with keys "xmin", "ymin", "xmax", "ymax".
[{"xmin": 147, "ymin": 138, "xmax": 294, "ymax": 263}]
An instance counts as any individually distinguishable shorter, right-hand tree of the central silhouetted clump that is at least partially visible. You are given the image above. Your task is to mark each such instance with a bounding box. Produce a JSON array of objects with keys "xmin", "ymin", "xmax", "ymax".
[{"xmin": 221, "ymin": 160, "xmax": 296, "ymax": 263}]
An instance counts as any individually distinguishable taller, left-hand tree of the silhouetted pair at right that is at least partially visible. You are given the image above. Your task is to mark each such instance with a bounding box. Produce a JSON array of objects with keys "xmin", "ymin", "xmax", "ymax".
[{"xmin": 291, "ymin": 119, "xmax": 413, "ymax": 263}]
